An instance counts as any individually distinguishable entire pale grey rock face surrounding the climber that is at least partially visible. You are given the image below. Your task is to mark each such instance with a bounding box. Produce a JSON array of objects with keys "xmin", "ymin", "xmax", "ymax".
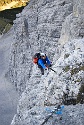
[{"xmin": 9, "ymin": 0, "xmax": 84, "ymax": 125}]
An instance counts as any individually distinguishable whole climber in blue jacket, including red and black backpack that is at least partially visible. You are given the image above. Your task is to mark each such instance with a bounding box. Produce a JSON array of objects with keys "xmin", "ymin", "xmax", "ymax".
[{"xmin": 33, "ymin": 53, "xmax": 51, "ymax": 75}]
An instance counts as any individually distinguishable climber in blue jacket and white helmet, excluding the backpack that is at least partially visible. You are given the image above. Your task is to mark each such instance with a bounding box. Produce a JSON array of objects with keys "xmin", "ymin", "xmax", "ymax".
[{"xmin": 38, "ymin": 53, "xmax": 51, "ymax": 75}]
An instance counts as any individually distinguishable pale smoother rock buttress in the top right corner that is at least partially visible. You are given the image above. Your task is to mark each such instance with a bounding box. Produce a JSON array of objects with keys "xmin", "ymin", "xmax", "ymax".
[{"xmin": 60, "ymin": 0, "xmax": 84, "ymax": 44}]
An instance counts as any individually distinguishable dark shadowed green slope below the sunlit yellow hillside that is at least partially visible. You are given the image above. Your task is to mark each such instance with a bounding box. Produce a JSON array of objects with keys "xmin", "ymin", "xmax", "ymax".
[{"xmin": 0, "ymin": 7, "xmax": 24, "ymax": 34}]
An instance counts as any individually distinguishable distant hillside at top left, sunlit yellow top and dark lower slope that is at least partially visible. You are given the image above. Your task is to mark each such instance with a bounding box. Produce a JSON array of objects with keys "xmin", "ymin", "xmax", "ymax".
[{"xmin": 0, "ymin": 0, "xmax": 29, "ymax": 34}]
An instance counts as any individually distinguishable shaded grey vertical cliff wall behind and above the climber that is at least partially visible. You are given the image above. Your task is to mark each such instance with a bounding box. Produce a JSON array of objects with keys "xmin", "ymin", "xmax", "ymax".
[{"xmin": 10, "ymin": 0, "xmax": 72, "ymax": 94}]
